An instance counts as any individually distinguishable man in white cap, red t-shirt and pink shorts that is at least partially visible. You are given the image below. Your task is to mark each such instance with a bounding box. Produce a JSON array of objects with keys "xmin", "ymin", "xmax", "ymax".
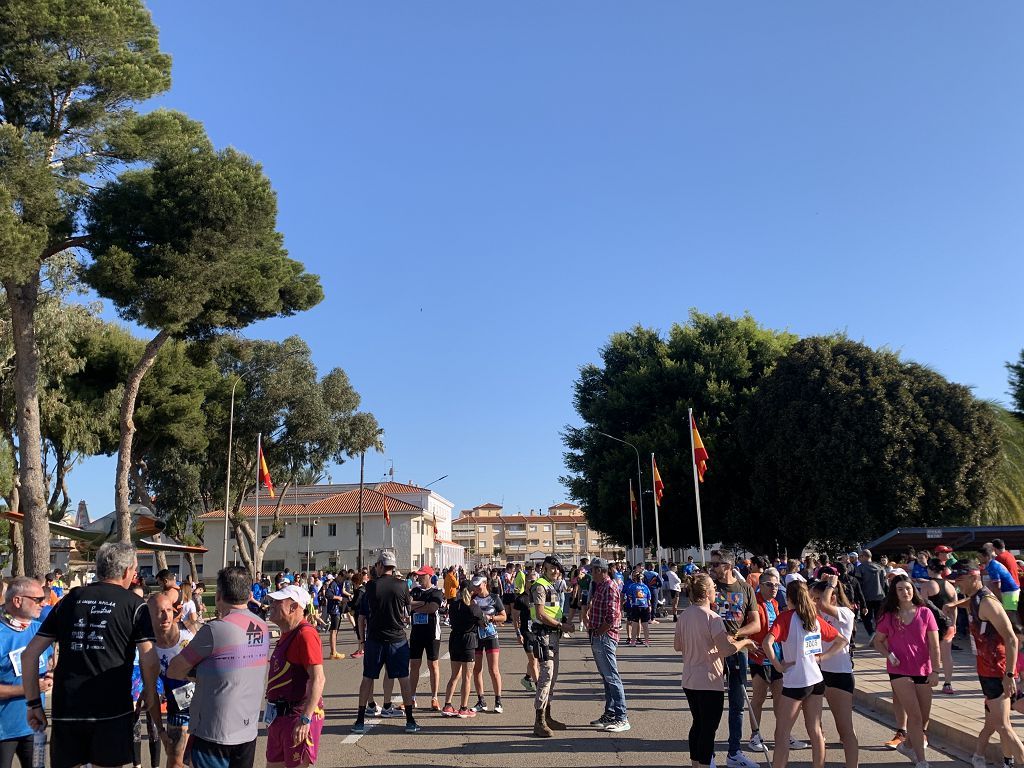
[{"xmin": 263, "ymin": 585, "xmax": 326, "ymax": 768}]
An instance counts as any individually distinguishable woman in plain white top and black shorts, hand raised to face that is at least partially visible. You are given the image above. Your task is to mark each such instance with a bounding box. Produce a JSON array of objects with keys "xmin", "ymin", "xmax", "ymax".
[{"xmin": 811, "ymin": 573, "xmax": 860, "ymax": 768}]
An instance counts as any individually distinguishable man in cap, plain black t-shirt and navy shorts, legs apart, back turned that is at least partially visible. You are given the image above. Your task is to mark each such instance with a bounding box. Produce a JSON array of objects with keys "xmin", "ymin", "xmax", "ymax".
[{"xmin": 352, "ymin": 550, "xmax": 420, "ymax": 733}]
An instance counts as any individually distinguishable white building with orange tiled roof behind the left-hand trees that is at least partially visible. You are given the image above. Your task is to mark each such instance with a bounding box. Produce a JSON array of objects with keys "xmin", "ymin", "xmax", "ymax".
[{"xmin": 200, "ymin": 482, "xmax": 464, "ymax": 574}]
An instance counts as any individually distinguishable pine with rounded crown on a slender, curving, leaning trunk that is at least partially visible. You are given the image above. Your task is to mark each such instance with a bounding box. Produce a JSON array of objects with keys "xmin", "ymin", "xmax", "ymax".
[{"xmin": 86, "ymin": 148, "xmax": 324, "ymax": 541}]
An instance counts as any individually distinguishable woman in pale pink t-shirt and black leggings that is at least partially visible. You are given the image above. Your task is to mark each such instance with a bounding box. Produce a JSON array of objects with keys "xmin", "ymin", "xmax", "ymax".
[{"xmin": 674, "ymin": 573, "xmax": 755, "ymax": 768}]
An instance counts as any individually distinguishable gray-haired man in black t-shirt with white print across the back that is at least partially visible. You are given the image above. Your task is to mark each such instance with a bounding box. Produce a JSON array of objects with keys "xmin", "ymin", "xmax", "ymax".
[{"xmin": 22, "ymin": 542, "xmax": 158, "ymax": 768}]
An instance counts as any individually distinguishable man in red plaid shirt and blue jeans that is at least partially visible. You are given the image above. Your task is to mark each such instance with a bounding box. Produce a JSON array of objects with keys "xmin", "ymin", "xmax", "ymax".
[{"xmin": 587, "ymin": 557, "xmax": 630, "ymax": 733}]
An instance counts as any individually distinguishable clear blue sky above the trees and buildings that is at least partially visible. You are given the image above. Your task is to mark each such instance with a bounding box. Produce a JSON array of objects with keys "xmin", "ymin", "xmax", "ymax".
[{"xmin": 72, "ymin": 0, "xmax": 1024, "ymax": 515}]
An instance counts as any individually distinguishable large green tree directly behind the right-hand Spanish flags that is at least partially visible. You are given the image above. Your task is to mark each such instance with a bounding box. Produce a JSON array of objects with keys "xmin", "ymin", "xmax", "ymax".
[{"xmin": 562, "ymin": 310, "xmax": 796, "ymax": 547}]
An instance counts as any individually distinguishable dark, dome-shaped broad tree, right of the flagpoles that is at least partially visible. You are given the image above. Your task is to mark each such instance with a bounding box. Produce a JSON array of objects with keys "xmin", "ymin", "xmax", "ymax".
[{"xmin": 739, "ymin": 336, "xmax": 999, "ymax": 555}]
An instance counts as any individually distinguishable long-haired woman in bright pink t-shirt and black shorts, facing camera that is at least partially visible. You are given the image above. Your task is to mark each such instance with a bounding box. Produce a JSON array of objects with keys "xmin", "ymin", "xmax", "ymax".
[{"xmin": 873, "ymin": 574, "xmax": 939, "ymax": 768}]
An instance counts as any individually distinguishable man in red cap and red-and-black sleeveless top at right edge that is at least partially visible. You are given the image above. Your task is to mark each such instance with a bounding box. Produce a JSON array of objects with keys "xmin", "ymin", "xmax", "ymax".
[{"xmin": 952, "ymin": 560, "xmax": 1024, "ymax": 768}]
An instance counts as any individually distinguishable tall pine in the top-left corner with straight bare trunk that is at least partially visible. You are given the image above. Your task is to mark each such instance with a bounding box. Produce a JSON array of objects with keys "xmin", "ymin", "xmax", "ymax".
[{"xmin": 0, "ymin": 0, "xmax": 210, "ymax": 572}]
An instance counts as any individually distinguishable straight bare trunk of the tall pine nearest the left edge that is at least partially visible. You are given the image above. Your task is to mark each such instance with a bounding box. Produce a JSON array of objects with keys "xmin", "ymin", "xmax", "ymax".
[{"xmin": 4, "ymin": 272, "xmax": 50, "ymax": 575}]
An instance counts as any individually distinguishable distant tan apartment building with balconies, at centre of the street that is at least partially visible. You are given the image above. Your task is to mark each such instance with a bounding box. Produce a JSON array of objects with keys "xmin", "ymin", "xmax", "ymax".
[{"xmin": 452, "ymin": 502, "xmax": 625, "ymax": 563}]
